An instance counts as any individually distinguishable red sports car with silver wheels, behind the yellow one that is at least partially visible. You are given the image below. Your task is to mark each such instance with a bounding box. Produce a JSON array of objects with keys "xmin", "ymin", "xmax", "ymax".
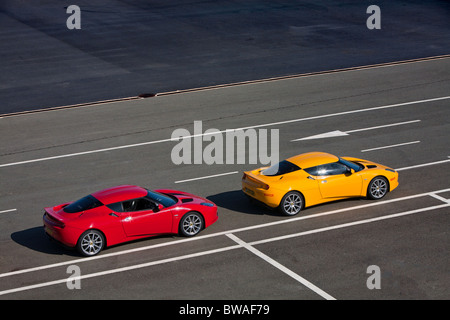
[{"xmin": 43, "ymin": 185, "xmax": 218, "ymax": 256}]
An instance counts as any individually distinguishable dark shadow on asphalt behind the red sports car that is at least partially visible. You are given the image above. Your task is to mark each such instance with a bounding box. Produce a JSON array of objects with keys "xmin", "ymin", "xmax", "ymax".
[{"xmin": 11, "ymin": 226, "xmax": 78, "ymax": 256}]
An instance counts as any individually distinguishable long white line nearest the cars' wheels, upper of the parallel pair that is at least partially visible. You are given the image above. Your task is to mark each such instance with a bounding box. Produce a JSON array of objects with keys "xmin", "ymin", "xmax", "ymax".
[{"xmin": 0, "ymin": 188, "xmax": 450, "ymax": 278}]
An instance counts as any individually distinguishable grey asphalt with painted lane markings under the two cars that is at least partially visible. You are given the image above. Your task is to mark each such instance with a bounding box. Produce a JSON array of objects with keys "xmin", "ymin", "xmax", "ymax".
[{"xmin": 0, "ymin": 58, "xmax": 450, "ymax": 300}]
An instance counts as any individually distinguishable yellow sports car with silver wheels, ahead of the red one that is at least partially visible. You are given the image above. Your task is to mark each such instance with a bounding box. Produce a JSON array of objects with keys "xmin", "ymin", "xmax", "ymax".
[{"xmin": 242, "ymin": 152, "xmax": 398, "ymax": 216}]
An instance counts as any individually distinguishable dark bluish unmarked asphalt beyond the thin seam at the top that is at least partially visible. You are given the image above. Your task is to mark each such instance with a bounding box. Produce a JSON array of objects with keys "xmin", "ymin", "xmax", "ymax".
[{"xmin": 0, "ymin": 0, "xmax": 450, "ymax": 114}]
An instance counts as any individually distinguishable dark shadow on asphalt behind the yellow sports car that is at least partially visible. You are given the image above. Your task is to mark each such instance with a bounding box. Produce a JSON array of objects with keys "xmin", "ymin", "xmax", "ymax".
[{"xmin": 206, "ymin": 190, "xmax": 280, "ymax": 216}]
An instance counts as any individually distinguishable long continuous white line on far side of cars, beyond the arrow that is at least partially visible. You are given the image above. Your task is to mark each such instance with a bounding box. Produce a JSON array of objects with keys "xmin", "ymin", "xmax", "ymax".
[{"xmin": 0, "ymin": 96, "xmax": 450, "ymax": 168}]
